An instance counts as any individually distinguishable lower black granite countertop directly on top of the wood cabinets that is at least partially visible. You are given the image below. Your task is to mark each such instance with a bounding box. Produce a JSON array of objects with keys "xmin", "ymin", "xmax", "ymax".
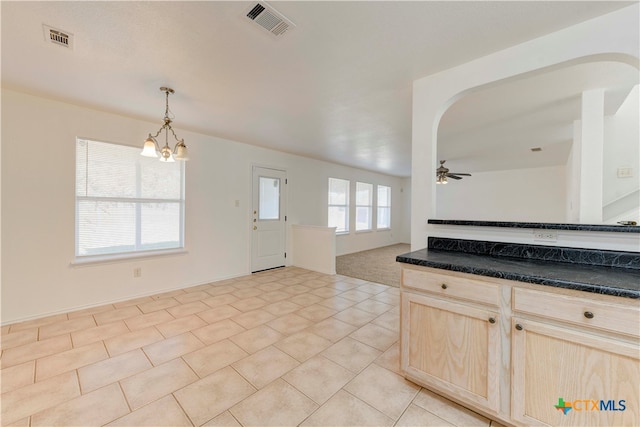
[{"xmin": 396, "ymin": 249, "xmax": 640, "ymax": 298}]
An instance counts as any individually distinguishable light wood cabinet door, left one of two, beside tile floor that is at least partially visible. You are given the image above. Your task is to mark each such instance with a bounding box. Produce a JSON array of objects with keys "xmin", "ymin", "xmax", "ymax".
[{"xmin": 401, "ymin": 292, "xmax": 500, "ymax": 412}]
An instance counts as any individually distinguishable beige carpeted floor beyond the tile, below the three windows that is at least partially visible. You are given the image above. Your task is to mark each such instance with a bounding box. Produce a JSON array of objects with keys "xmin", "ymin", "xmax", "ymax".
[{"xmin": 336, "ymin": 243, "xmax": 411, "ymax": 287}]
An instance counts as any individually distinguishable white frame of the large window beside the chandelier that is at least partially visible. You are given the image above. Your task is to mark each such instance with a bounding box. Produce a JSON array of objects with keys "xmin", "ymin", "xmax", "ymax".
[{"xmin": 72, "ymin": 137, "xmax": 186, "ymax": 265}]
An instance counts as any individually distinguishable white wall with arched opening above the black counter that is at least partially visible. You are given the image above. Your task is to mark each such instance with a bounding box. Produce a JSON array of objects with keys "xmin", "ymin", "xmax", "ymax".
[{"xmin": 411, "ymin": 3, "xmax": 640, "ymax": 251}]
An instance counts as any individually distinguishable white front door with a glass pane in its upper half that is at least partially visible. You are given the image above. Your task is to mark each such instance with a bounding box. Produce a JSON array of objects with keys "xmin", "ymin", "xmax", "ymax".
[{"xmin": 251, "ymin": 166, "xmax": 287, "ymax": 273}]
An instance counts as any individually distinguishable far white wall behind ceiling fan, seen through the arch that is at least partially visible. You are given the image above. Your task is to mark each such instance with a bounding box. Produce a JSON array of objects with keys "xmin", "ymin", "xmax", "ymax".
[{"xmin": 436, "ymin": 166, "xmax": 566, "ymax": 222}]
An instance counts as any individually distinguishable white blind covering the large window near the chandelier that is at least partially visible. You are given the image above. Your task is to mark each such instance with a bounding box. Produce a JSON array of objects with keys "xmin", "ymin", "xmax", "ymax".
[{"xmin": 76, "ymin": 138, "xmax": 184, "ymax": 257}]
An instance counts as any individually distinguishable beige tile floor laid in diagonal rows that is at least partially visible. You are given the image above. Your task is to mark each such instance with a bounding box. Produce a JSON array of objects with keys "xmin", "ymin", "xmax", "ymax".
[{"xmin": 0, "ymin": 267, "xmax": 496, "ymax": 426}]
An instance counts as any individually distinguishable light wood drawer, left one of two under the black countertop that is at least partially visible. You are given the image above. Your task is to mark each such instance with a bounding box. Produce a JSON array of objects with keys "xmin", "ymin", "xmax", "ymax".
[{"xmin": 402, "ymin": 268, "xmax": 500, "ymax": 306}]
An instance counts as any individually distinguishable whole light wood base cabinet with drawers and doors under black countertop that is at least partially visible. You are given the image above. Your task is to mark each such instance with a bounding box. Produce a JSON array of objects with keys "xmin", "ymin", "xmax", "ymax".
[{"xmin": 400, "ymin": 266, "xmax": 640, "ymax": 426}]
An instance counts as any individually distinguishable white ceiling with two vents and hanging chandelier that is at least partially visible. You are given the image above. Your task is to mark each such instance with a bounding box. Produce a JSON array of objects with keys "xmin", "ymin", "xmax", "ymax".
[{"xmin": 1, "ymin": 1, "xmax": 637, "ymax": 176}]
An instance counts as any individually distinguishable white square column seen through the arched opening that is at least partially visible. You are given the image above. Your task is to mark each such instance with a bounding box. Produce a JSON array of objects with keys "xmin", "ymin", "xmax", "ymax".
[{"xmin": 579, "ymin": 89, "xmax": 604, "ymax": 224}]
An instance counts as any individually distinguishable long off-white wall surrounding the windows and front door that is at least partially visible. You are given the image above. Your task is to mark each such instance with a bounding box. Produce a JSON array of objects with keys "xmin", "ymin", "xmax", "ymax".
[{"xmin": 1, "ymin": 90, "xmax": 404, "ymax": 324}]
